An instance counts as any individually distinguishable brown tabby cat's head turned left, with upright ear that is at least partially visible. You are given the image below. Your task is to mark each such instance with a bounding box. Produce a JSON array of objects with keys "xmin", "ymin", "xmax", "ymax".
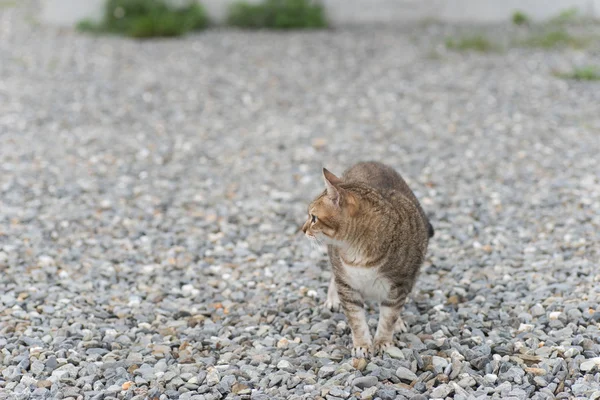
[{"xmin": 302, "ymin": 168, "xmax": 358, "ymax": 244}]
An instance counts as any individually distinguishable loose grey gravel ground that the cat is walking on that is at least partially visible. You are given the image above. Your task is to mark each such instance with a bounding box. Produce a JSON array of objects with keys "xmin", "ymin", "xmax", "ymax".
[{"xmin": 0, "ymin": 2, "xmax": 600, "ymax": 400}]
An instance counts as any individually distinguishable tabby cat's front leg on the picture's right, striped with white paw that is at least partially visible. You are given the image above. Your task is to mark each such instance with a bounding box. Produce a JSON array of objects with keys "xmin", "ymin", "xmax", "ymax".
[{"xmin": 375, "ymin": 285, "xmax": 409, "ymax": 353}]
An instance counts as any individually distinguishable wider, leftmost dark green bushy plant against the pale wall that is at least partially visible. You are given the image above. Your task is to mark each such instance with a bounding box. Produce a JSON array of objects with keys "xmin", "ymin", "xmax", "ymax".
[{"xmin": 77, "ymin": 0, "xmax": 208, "ymax": 38}]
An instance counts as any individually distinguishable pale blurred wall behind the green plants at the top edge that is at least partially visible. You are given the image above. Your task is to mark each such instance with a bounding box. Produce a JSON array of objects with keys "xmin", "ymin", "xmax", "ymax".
[{"xmin": 42, "ymin": 0, "xmax": 600, "ymax": 26}]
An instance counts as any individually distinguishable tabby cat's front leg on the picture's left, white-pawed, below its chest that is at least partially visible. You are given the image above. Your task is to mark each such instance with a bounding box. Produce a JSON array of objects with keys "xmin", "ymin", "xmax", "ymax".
[{"xmin": 335, "ymin": 279, "xmax": 373, "ymax": 358}]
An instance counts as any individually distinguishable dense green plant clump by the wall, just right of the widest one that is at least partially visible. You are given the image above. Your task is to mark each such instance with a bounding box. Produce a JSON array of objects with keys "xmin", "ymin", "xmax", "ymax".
[{"xmin": 227, "ymin": 0, "xmax": 327, "ymax": 29}]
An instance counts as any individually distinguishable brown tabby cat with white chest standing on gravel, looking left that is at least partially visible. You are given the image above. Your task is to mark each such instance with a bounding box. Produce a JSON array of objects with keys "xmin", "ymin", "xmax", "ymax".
[{"xmin": 302, "ymin": 162, "xmax": 434, "ymax": 358}]
